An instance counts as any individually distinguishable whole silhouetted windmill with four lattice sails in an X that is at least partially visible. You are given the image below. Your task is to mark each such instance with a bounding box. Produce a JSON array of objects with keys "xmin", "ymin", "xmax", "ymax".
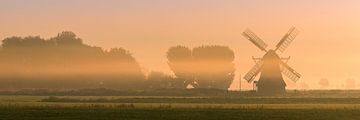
[{"xmin": 242, "ymin": 27, "xmax": 301, "ymax": 94}]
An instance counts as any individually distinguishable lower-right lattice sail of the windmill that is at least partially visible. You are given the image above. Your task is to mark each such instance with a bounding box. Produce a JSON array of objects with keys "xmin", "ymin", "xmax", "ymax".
[{"xmin": 280, "ymin": 61, "xmax": 301, "ymax": 82}]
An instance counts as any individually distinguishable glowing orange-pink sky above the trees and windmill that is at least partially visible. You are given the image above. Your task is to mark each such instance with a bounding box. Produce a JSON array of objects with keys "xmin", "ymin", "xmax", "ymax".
[{"xmin": 0, "ymin": 0, "xmax": 360, "ymax": 88}]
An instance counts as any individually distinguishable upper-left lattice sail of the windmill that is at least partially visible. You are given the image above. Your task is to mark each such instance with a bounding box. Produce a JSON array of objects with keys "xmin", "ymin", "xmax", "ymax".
[{"xmin": 242, "ymin": 29, "xmax": 268, "ymax": 51}]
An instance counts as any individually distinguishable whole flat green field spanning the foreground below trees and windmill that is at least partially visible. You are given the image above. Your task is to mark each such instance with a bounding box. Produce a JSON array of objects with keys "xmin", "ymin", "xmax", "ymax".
[{"xmin": 0, "ymin": 91, "xmax": 360, "ymax": 120}]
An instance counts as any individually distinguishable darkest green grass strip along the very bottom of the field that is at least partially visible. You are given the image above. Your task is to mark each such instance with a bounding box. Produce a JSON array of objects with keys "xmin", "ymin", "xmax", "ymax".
[{"xmin": 0, "ymin": 105, "xmax": 360, "ymax": 120}]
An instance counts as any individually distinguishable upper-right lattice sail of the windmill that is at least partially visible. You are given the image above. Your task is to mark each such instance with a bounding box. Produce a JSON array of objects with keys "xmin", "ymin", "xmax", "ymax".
[{"xmin": 275, "ymin": 27, "xmax": 299, "ymax": 52}]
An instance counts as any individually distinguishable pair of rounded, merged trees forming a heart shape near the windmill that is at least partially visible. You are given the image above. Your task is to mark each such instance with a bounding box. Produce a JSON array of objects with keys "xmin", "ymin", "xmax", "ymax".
[{"xmin": 167, "ymin": 46, "xmax": 235, "ymax": 89}]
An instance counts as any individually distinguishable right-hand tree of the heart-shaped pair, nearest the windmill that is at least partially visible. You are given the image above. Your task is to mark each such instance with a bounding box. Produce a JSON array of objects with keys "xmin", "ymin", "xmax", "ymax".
[{"xmin": 193, "ymin": 46, "xmax": 235, "ymax": 89}]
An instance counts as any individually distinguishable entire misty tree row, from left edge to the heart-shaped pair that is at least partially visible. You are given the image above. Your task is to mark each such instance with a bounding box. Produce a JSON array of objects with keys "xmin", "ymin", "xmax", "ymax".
[{"xmin": 0, "ymin": 32, "xmax": 235, "ymax": 89}]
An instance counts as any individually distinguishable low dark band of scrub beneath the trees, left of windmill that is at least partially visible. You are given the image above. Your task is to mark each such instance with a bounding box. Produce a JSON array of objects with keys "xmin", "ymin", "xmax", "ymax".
[{"xmin": 0, "ymin": 88, "xmax": 236, "ymax": 96}]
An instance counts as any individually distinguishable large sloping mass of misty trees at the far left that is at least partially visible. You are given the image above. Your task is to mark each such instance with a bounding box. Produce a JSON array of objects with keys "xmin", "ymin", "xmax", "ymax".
[{"xmin": 0, "ymin": 32, "xmax": 145, "ymax": 89}]
